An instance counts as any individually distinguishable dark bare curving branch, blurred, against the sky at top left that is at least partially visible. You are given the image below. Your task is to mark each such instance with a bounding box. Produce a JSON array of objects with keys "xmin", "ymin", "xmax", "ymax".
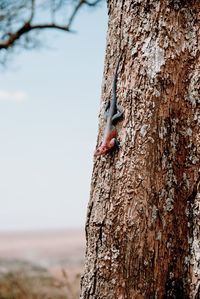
[{"xmin": 0, "ymin": 0, "xmax": 102, "ymax": 50}]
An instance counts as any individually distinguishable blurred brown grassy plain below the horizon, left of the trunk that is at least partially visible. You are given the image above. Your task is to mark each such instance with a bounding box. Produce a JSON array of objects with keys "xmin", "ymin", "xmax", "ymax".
[{"xmin": 0, "ymin": 230, "xmax": 85, "ymax": 299}]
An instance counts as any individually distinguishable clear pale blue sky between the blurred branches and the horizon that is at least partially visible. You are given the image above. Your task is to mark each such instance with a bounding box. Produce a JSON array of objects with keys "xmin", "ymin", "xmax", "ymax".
[{"xmin": 0, "ymin": 1, "xmax": 107, "ymax": 231}]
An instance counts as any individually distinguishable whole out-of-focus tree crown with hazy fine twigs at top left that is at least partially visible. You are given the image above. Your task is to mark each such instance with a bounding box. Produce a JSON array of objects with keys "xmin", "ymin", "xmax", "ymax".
[{"xmin": 0, "ymin": 0, "xmax": 102, "ymax": 64}]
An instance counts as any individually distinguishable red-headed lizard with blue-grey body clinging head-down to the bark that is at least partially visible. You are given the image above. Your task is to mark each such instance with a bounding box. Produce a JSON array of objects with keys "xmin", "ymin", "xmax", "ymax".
[{"xmin": 94, "ymin": 56, "xmax": 123, "ymax": 156}]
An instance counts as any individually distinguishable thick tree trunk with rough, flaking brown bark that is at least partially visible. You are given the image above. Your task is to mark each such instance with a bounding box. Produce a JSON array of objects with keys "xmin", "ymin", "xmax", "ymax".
[{"xmin": 81, "ymin": 0, "xmax": 200, "ymax": 299}]
